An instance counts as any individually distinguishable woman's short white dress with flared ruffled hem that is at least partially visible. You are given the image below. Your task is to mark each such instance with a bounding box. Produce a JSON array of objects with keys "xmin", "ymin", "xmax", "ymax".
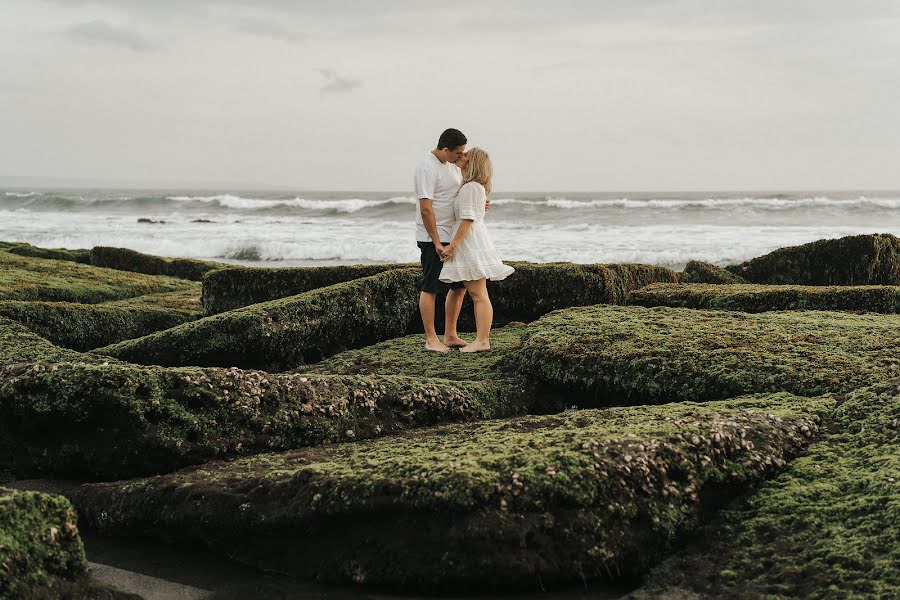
[{"xmin": 440, "ymin": 181, "xmax": 515, "ymax": 283}]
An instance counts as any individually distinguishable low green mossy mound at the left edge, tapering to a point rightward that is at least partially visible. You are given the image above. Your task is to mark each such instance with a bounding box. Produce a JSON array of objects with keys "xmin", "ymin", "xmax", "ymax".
[{"xmin": 0, "ymin": 250, "xmax": 191, "ymax": 304}]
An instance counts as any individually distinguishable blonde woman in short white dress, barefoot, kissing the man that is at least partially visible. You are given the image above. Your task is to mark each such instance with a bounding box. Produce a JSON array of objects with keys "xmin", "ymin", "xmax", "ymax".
[{"xmin": 440, "ymin": 148, "xmax": 515, "ymax": 352}]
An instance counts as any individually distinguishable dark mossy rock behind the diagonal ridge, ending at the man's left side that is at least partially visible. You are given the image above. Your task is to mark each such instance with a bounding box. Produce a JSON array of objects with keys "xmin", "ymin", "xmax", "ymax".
[{"xmin": 203, "ymin": 263, "xmax": 415, "ymax": 314}]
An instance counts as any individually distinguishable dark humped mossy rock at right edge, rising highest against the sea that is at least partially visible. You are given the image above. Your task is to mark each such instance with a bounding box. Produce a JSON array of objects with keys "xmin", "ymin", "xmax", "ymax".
[{"xmin": 726, "ymin": 234, "xmax": 900, "ymax": 285}]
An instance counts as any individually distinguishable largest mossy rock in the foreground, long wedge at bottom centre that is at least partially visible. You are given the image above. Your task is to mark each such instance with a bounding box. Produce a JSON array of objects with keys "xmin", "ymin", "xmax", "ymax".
[{"xmin": 72, "ymin": 394, "xmax": 828, "ymax": 592}]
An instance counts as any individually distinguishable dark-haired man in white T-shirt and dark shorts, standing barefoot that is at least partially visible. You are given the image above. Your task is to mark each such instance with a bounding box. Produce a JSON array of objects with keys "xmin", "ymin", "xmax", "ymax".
[{"xmin": 415, "ymin": 129, "xmax": 468, "ymax": 353}]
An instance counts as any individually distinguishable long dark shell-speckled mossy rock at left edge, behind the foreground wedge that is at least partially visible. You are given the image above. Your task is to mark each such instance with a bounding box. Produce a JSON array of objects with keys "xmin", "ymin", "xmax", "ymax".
[{"xmin": 0, "ymin": 363, "xmax": 533, "ymax": 479}]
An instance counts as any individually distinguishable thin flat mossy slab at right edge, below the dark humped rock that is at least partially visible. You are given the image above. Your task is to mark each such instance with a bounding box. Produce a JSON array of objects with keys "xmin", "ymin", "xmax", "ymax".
[{"xmin": 628, "ymin": 283, "xmax": 900, "ymax": 314}]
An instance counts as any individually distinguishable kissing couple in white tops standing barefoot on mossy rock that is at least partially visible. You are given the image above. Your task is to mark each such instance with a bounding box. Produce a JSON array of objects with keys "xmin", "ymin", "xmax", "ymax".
[{"xmin": 414, "ymin": 129, "xmax": 514, "ymax": 353}]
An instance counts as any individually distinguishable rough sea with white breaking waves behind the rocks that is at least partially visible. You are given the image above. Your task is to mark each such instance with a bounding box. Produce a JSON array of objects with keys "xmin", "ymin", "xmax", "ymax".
[{"xmin": 0, "ymin": 189, "xmax": 900, "ymax": 269}]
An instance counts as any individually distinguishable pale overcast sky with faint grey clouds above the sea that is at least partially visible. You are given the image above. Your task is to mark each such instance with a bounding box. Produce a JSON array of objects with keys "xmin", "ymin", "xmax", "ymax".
[{"xmin": 0, "ymin": 0, "xmax": 900, "ymax": 191}]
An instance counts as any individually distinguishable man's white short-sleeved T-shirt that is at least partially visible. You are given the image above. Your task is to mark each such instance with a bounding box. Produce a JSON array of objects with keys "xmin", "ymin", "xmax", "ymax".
[{"xmin": 415, "ymin": 152, "xmax": 462, "ymax": 244}]
